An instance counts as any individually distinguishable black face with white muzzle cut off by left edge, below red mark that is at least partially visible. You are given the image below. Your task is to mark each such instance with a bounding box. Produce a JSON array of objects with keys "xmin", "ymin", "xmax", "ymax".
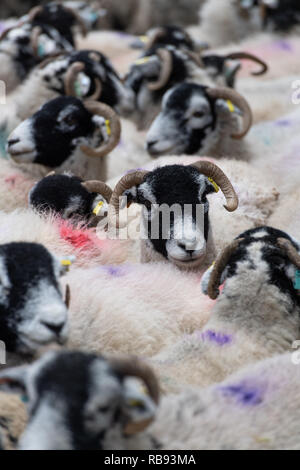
[{"xmin": 0, "ymin": 243, "xmax": 68, "ymax": 354}]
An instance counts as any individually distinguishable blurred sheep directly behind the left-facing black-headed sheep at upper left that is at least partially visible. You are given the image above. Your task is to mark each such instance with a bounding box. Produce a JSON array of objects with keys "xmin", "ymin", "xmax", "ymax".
[{"xmin": 1, "ymin": 50, "xmax": 134, "ymax": 132}]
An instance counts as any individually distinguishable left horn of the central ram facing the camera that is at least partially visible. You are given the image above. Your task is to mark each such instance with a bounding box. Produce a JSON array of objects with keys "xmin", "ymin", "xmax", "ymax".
[{"xmin": 108, "ymin": 170, "xmax": 149, "ymax": 227}]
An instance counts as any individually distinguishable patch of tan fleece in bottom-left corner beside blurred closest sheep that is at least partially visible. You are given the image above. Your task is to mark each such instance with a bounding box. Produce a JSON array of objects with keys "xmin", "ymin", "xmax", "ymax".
[{"xmin": 0, "ymin": 392, "xmax": 28, "ymax": 450}]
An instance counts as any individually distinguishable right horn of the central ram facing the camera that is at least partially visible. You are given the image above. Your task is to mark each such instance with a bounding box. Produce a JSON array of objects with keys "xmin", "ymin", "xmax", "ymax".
[{"xmin": 190, "ymin": 160, "xmax": 239, "ymax": 212}]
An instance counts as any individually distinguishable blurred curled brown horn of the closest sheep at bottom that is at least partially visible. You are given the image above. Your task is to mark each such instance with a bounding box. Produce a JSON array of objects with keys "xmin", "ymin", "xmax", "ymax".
[{"xmin": 110, "ymin": 358, "xmax": 160, "ymax": 435}]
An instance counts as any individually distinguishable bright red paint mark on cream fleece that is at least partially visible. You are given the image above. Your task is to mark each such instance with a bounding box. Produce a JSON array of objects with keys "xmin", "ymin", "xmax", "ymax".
[{"xmin": 59, "ymin": 220, "xmax": 104, "ymax": 251}]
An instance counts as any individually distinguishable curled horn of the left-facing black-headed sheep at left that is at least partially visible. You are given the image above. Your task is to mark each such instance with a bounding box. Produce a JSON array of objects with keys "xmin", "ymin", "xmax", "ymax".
[{"xmin": 81, "ymin": 101, "xmax": 121, "ymax": 157}]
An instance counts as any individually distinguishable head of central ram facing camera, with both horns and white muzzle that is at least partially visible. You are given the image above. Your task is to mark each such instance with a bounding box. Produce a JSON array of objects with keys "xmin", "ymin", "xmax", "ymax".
[{"xmin": 109, "ymin": 161, "xmax": 238, "ymax": 270}]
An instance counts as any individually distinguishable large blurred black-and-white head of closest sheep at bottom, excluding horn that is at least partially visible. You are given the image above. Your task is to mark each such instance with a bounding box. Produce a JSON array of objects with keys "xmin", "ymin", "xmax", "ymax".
[{"xmin": 0, "ymin": 351, "xmax": 157, "ymax": 450}]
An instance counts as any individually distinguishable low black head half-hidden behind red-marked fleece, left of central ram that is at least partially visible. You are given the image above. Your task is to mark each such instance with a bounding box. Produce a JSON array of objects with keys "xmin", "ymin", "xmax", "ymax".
[{"xmin": 29, "ymin": 174, "xmax": 108, "ymax": 222}]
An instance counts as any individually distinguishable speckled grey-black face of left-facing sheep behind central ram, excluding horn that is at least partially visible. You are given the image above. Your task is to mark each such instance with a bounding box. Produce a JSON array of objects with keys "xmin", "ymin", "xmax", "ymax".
[{"xmin": 146, "ymin": 83, "xmax": 217, "ymax": 157}]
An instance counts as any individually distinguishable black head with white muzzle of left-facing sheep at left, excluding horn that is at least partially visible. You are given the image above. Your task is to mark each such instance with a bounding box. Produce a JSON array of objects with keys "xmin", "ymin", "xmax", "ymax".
[{"xmin": 7, "ymin": 97, "xmax": 108, "ymax": 168}]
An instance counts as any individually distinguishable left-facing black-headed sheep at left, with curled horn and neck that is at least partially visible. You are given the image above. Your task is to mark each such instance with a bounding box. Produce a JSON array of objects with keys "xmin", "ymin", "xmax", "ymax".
[{"xmin": 7, "ymin": 96, "xmax": 121, "ymax": 180}]
